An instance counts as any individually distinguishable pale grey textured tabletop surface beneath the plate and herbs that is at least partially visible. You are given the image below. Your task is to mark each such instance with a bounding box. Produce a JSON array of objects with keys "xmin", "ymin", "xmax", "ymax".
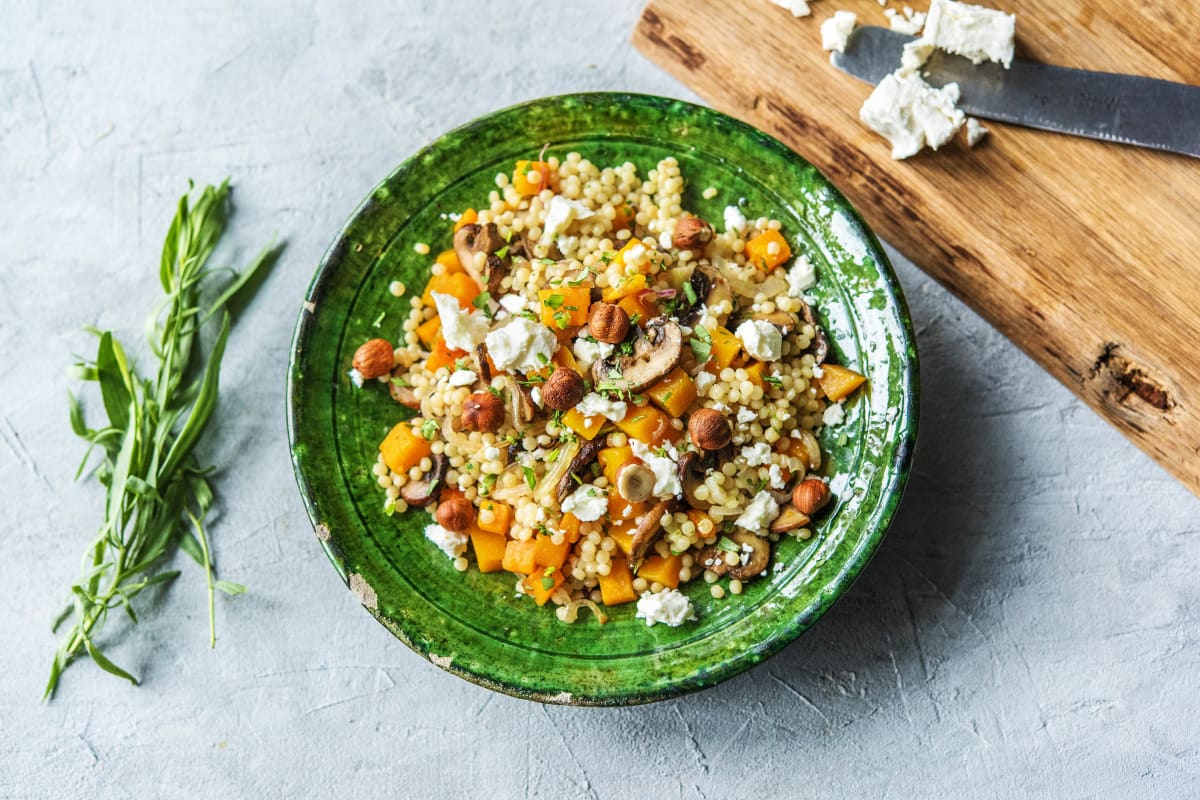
[{"xmin": 0, "ymin": 0, "xmax": 1200, "ymax": 798}]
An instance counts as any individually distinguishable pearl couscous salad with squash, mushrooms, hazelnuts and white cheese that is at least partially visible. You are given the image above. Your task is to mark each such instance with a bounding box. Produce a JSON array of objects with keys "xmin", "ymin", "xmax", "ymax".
[{"xmin": 350, "ymin": 152, "xmax": 865, "ymax": 625}]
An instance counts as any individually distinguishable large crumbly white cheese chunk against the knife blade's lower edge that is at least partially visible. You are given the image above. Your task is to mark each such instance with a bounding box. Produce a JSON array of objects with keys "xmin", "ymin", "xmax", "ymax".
[{"xmin": 859, "ymin": 70, "xmax": 966, "ymax": 160}]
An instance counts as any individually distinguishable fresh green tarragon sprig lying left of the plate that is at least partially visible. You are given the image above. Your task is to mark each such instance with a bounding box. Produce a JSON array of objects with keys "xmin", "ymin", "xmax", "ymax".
[{"xmin": 43, "ymin": 180, "xmax": 281, "ymax": 699}]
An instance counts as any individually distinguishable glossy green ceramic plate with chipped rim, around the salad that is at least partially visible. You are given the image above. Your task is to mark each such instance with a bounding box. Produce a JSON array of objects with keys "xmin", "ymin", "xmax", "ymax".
[{"xmin": 288, "ymin": 94, "xmax": 917, "ymax": 705}]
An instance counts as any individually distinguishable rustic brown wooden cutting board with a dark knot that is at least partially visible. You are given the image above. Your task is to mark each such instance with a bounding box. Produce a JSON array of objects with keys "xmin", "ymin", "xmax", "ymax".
[{"xmin": 634, "ymin": 0, "xmax": 1200, "ymax": 494}]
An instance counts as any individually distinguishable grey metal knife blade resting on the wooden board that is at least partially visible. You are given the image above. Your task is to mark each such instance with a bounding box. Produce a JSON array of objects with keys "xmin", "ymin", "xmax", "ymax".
[{"xmin": 833, "ymin": 25, "xmax": 1200, "ymax": 158}]
